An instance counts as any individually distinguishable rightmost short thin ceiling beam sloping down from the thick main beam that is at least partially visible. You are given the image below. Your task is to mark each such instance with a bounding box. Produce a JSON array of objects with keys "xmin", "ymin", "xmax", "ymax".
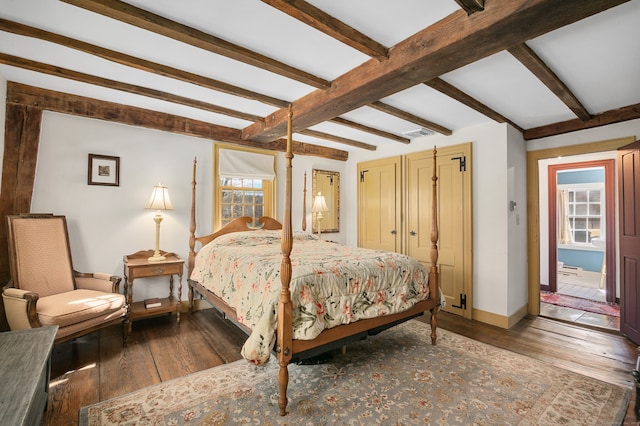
[{"xmin": 507, "ymin": 43, "xmax": 591, "ymax": 121}]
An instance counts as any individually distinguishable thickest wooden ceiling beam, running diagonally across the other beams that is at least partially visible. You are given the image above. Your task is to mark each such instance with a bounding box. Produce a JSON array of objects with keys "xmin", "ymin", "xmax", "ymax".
[{"xmin": 242, "ymin": 0, "xmax": 628, "ymax": 142}]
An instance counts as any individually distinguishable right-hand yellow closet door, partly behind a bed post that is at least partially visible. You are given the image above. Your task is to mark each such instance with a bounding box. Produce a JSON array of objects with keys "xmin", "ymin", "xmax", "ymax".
[{"xmin": 406, "ymin": 144, "xmax": 473, "ymax": 318}]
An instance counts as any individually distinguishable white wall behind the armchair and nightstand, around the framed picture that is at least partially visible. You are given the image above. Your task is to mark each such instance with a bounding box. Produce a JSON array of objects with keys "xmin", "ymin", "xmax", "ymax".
[{"xmin": 31, "ymin": 112, "xmax": 212, "ymax": 300}]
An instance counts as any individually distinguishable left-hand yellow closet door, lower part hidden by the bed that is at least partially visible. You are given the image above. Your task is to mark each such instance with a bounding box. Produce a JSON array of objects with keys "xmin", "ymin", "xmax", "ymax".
[{"xmin": 358, "ymin": 156, "xmax": 402, "ymax": 252}]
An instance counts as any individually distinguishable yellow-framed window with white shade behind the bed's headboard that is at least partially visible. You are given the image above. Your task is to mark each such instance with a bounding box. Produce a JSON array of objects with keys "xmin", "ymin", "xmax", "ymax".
[{"xmin": 214, "ymin": 145, "xmax": 275, "ymax": 229}]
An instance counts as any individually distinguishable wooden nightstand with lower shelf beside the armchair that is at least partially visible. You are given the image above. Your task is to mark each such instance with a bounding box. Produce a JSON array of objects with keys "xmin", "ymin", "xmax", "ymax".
[{"xmin": 123, "ymin": 250, "xmax": 184, "ymax": 333}]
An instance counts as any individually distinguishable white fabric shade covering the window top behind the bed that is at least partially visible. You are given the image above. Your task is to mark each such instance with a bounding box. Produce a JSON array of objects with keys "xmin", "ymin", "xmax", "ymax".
[{"xmin": 218, "ymin": 149, "xmax": 276, "ymax": 180}]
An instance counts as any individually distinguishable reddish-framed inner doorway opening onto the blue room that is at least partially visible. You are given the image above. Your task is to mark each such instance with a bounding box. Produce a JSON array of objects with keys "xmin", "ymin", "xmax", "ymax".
[{"xmin": 540, "ymin": 158, "xmax": 620, "ymax": 330}]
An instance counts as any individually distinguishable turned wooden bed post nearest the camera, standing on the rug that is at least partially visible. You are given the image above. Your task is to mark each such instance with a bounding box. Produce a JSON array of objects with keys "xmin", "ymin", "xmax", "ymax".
[{"xmin": 276, "ymin": 104, "xmax": 293, "ymax": 416}]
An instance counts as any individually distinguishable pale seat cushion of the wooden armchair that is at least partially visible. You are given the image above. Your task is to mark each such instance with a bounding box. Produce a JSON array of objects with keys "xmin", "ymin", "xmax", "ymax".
[{"xmin": 36, "ymin": 289, "xmax": 125, "ymax": 327}]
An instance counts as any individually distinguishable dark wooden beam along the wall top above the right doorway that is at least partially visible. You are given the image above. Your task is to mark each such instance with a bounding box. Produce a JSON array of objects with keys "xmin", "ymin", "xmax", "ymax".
[{"xmin": 523, "ymin": 104, "xmax": 640, "ymax": 140}]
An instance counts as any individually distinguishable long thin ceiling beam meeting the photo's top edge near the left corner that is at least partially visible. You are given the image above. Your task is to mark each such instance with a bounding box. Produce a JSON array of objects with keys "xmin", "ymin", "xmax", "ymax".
[{"xmin": 61, "ymin": 0, "xmax": 331, "ymax": 89}]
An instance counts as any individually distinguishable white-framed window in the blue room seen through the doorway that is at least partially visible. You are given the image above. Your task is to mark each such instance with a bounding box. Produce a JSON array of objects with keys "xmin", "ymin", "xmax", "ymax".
[{"xmin": 558, "ymin": 184, "xmax": 605, "ymax": 245}]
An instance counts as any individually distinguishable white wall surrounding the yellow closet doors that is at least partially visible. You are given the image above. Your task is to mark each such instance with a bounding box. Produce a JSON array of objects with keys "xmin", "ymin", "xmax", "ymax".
[{"xmin": 342, "ymin": 123, "xmax": 526, "ymax": 315}]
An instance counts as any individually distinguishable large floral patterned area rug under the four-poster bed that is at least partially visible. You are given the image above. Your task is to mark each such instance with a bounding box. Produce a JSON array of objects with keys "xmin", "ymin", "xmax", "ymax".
[{"xmin": 80, "ymin": 320, "xmax": 632, "ymax": 425}]
